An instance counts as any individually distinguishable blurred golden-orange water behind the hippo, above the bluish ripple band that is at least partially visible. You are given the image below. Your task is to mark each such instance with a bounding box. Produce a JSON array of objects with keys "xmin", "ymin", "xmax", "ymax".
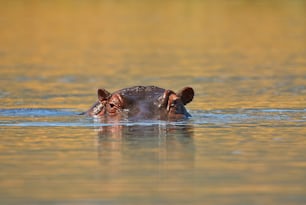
[{"xmin": 0, "ymin": 0, "xmax": 306, "ymax": 110}]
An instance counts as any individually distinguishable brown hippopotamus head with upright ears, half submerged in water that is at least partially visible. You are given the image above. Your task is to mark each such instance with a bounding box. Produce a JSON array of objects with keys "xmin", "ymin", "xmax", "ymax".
[{"xmin": 82, "ymin": 86, "xmax": 194, "ymax": 120}]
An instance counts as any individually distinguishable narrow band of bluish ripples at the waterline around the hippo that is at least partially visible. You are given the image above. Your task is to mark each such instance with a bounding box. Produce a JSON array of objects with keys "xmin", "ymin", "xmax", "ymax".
[{"xmin": 0, "ymin": 108, "xmax": 306, "ymax": 127}]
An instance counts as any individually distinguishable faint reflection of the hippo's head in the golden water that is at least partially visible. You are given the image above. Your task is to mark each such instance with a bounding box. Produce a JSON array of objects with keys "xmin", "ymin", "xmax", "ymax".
[{"xmin": 98, "ymin": 124, "xmax": 195, "ymax": 183}]
